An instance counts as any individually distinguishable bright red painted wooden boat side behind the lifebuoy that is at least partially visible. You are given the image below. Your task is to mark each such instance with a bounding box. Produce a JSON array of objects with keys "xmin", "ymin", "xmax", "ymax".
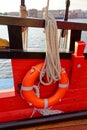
[{"xmin": 0, "ymin": 55, "xmax": 87, "ymax": 122}]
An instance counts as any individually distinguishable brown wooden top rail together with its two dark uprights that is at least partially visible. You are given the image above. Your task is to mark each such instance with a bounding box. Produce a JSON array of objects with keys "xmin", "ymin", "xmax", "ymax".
[{"xmin": 0, "ymin": 16, "xmax": 87, "ymax": 51}]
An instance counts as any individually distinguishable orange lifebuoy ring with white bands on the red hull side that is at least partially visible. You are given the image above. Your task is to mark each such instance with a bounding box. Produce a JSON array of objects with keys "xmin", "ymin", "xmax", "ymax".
[{"xmin": 21, "ymin": 63, "xmax": 69, "ymax": 108}]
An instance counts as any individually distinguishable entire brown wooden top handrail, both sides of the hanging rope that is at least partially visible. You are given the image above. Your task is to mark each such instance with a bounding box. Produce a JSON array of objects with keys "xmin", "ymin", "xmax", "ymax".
[{"xmin": 0, "ymin": 16, "xmax": 87, "ymax": 31}]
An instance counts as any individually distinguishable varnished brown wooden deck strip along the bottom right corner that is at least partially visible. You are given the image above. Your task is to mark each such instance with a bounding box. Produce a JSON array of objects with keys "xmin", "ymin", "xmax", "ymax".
[{"xmin": 15, "ymin": 119, "xmax": 87, "ymax": 130}]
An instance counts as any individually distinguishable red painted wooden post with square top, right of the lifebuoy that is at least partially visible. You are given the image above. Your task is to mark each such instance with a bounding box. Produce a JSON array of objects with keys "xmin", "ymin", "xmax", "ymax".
[{"xmin": 70, "ymin": 41, "xmax": 87, "ymax": 89}]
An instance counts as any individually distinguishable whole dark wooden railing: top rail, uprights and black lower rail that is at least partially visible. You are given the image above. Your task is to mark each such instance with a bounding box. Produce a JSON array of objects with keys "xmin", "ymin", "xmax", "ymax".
[{"xmin": 0, "ymin": 16, "xmax": 87, "ymax": 58}]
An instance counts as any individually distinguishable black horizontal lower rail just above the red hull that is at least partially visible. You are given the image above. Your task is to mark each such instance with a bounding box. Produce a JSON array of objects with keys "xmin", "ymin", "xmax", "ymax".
[{"xmin": 0, "ymin": 49, "xmax": 71, "ymax": 60}]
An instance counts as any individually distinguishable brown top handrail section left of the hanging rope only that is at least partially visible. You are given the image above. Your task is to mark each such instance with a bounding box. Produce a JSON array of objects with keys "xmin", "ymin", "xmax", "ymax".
[{"xmin": 0, "ymin": 16, "xmax": 45, "ymax": 27}]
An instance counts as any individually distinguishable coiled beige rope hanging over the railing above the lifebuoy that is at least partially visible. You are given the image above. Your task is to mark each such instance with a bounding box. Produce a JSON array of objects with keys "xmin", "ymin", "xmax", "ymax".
[{"xmin": 40, "ymin": 0, "xmax": 61, "ymax": 85}]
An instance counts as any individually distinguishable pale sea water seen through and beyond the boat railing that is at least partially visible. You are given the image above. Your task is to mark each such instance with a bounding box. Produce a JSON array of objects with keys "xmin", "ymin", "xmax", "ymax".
[{"xmin": 0, "ymin": 19, "xmax": 87, "ymax": 90}]
